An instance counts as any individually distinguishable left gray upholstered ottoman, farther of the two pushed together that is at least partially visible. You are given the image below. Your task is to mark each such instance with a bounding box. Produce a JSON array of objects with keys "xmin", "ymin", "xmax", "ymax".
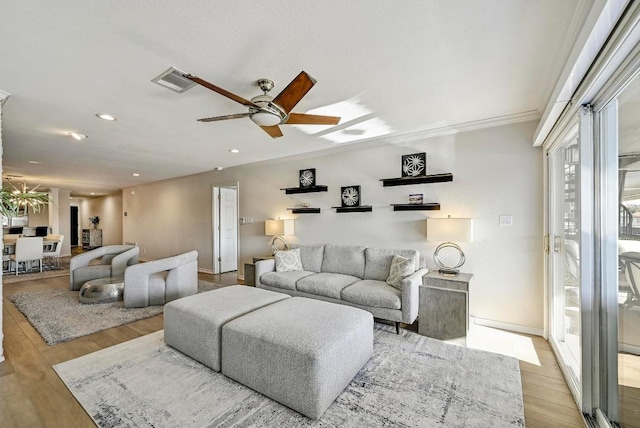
[{"xmin": 164, "ymin": 285, "xmax": 290, "ymax": 371}]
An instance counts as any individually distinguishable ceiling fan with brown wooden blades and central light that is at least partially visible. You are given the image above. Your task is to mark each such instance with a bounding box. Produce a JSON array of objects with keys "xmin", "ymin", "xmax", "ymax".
[{"xmin": 183, "ymin": 71, "xmax": 340, "ymax": 138}]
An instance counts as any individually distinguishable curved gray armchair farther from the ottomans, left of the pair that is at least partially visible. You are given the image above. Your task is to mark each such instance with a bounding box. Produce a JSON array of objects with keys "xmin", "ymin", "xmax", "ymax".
[{"xmin": 69, "ymin": 245, "xmax": 140, "ymax": 290}]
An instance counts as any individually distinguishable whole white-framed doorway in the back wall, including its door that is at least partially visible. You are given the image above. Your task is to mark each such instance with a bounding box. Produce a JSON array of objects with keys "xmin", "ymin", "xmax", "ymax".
[{"xmin": 211, "ymin": 183, "xmax": 239, "ymax": 273}]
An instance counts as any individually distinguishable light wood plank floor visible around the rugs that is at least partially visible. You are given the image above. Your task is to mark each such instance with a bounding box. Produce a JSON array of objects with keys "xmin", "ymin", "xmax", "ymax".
[{"xmin": 0, "ymin": 273, "xmax": 584, "ymax": 428}]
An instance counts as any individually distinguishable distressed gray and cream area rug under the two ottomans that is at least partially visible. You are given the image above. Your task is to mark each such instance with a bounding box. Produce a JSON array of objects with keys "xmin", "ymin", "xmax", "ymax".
[{"xmin": 54, "ymin": 324, "xmax": 524, "ymax": 428}]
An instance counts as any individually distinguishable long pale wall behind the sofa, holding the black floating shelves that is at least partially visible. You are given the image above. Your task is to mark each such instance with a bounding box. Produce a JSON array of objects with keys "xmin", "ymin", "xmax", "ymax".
[{"xmin": 123, "ymin": 122, "xmax": 543, "ymax": 329}]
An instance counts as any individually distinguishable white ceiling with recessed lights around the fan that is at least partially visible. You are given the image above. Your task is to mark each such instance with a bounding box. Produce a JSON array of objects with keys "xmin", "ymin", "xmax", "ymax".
[{"xmin": 0, "ymin": 0, "xmax": 590, "ymax": 195}]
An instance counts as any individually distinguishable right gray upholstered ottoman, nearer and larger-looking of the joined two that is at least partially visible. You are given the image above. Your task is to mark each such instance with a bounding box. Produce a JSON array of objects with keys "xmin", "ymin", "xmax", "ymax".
[{"xmin": 221, "ymin": 297, "xmax": 373, "ymax": 419}]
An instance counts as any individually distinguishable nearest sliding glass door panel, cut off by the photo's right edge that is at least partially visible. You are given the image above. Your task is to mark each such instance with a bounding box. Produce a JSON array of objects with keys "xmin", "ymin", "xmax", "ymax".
[{"xmin": 598, "ymin": 71, "xmax": 640, "ymax": 428}]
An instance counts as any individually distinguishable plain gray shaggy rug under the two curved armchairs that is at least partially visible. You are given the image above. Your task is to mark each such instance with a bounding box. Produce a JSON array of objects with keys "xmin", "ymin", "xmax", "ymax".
[{"xmin": 8, "ymin": 281, "xmax": 223, "ymax": 345}]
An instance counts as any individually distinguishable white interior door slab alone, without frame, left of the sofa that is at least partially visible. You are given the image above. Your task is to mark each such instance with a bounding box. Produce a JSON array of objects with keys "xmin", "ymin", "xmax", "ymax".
[{"xmin": 219, "ymin": 187, "xmax": 238, "ymax": 273}]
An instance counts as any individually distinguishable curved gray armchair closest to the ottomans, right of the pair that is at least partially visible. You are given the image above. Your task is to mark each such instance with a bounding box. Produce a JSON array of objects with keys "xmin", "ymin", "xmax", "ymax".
[{"xmin": 123, "ymin": 251, "xmax": 198, "ymax": 308}]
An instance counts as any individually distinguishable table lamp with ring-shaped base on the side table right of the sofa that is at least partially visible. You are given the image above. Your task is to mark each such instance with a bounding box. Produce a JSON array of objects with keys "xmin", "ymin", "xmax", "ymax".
[{"xmin": 427, "ymin": 216, "xmax": 473, "ymax": 275}]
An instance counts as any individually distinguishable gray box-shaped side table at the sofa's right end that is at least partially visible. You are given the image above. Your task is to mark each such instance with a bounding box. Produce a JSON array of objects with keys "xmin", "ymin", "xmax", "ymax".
[{"xmin": 418, "ymin": 271, "xmax": 473, "ymax": 340}]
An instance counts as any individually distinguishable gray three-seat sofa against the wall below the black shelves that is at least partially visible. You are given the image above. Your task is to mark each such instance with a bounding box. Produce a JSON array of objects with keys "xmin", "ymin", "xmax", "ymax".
[{"xmin": 255, "ymin": 244, "xmax": 428, "ymax": 331}]
